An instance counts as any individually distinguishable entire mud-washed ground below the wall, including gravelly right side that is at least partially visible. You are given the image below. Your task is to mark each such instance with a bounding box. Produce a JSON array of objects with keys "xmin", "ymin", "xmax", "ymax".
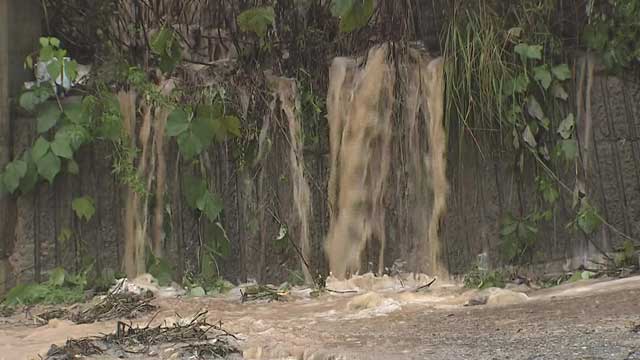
[{"xmin": 0, "ymin": 277, "xmax": 640, "ymax": 360}]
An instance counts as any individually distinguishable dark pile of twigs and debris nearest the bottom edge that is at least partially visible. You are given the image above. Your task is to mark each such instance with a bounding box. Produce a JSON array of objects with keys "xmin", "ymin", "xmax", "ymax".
[{"xmin": 45, "ymin": 311, "xmax": 240, "ymax": 360}]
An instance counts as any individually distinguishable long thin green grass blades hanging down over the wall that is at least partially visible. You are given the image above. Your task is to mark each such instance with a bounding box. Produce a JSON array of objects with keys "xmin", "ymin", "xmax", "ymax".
[{"xmin": 442, "ymin": 1, "xmax": 514, "ymax": 145}]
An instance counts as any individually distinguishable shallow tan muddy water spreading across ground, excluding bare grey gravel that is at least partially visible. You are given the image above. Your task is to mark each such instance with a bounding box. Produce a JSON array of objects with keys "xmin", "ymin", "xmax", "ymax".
[{"xmin": 0, "ymin": 274, "xmax": 640, "ymax": 360}]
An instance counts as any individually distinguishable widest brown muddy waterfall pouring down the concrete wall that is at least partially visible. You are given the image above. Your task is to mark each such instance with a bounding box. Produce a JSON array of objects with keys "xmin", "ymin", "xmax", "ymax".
[{"xmin": 325, "ymin": 44, "xmax": 448, "ymax": 279}]
